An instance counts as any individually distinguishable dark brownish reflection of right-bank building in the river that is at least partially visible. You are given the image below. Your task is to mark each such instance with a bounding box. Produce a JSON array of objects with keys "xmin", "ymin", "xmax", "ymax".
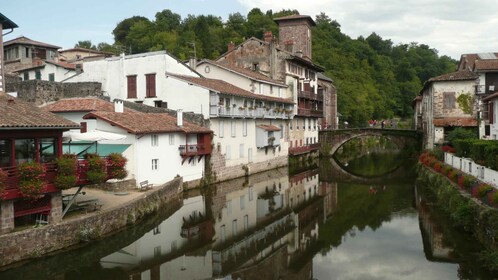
[{"xmin": 416, "ymin": 189, "xmax": 456, "ymax": 262}]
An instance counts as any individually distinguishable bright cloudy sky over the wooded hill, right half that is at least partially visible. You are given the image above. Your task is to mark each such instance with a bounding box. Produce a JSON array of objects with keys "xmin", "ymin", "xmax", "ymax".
[{"xmin": 239, "ymin": 0, "xmax": 498, "ymax": 59}]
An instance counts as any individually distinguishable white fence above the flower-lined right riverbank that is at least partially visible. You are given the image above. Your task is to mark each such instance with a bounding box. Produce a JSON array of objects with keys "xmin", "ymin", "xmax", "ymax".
[{"xmin": 444, "ymin": 153, "xmax": 498, "ymax": 189}]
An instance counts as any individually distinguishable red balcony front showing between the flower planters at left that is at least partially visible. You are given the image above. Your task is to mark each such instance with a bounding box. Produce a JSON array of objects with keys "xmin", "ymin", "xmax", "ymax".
[{"xmin": 2, "ymin": 160, "xmax": 115, "ymax": 200}]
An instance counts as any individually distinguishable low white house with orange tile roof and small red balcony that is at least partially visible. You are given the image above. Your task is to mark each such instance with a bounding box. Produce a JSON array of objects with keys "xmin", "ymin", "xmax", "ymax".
[{"xmin": 42, "ymin": 98, "xmax": 211, "ymax": 185}]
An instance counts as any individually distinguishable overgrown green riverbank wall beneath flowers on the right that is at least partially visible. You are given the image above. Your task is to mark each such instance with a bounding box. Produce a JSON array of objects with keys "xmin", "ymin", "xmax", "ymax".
[{"xmin": 417, "ymin": 164, "xmax": 498, "ymax": 251}]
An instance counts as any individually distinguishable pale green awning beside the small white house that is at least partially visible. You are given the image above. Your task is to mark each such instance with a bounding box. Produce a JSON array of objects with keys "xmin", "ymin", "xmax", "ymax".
[{"xmin": 62, "ymin": 142, "xmax": 130, "ymax": 157}]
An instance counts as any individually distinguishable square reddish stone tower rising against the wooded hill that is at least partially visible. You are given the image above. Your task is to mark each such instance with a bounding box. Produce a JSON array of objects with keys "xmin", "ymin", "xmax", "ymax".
[{"xmin": 273, "ymin": 15, "xmax": 316, "ymax": 61}]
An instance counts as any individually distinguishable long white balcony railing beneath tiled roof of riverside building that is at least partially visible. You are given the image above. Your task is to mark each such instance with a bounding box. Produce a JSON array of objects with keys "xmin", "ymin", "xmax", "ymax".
[{"xmin": 210, "ymin": 106, "xmax": 293, "ymax": 119}]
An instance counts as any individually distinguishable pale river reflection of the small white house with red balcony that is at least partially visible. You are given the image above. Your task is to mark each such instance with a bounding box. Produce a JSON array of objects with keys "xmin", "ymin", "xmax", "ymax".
[{"xmin": 100, "ymin": 196, "xmax": 212, "ymax": 279}]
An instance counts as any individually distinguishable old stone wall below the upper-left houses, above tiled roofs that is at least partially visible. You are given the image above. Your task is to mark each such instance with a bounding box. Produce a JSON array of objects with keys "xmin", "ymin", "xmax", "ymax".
[{"xmin": 6, "ymin": 80, "xmax": 103, "ymax": 105}]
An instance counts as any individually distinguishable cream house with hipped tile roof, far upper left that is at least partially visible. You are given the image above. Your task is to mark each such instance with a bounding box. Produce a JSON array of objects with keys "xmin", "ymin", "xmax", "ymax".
[{"xmin": 3, "ymin": 36, "xmax": 61, "ymax": 73}]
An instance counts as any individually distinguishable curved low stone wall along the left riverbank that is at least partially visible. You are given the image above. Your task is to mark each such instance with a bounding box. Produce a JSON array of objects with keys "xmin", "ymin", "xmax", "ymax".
[{"xmin": 0, "ymin": 178, "xmax": 183, "ymax": 266}]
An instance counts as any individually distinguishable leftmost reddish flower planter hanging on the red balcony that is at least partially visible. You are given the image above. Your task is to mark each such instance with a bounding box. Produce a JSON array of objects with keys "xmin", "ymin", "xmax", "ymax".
[{"xmin": 17, "ymin": 161, "xmax": 45, "ymax": 200}]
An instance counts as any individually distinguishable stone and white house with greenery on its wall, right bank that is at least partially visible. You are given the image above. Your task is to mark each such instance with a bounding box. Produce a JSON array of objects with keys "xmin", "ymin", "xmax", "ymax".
[{"xmin": 416, "ymin": 70, "xmax": 478, "ymax": 149}]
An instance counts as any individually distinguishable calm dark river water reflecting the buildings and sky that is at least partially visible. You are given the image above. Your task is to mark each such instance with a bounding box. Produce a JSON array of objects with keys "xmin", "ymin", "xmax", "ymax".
[{"xmin": 0, "ymin": 154, "xmax": 498, "ymax": 280}]
